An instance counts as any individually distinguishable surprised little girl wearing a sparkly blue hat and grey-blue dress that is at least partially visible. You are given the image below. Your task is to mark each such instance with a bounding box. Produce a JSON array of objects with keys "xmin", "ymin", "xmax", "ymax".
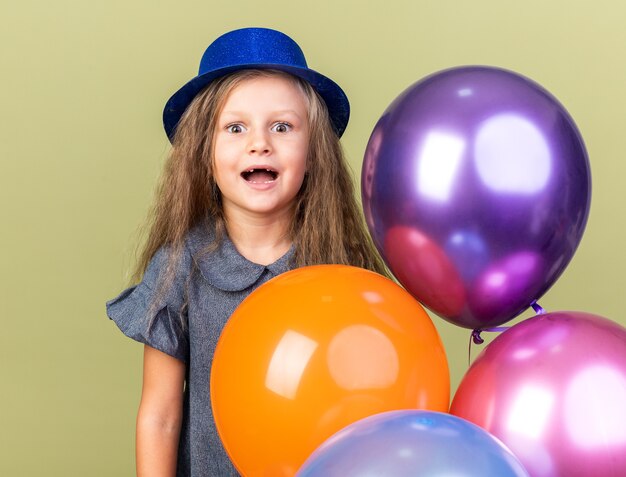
[{"xmin": 107, "ymin": 28, "xmax": 385, "ymax": 477}]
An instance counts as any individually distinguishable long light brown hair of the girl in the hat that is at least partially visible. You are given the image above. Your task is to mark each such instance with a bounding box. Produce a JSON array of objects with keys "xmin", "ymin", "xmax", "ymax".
[{"xmin": 133, "ymin": 70, "xmax": 387, "ymax": 288}]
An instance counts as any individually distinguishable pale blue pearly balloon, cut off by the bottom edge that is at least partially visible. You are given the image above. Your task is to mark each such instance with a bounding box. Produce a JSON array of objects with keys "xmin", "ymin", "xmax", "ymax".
[{"xmin": 297, "ymin": 410, "xmax": 529, "ymax": 477}]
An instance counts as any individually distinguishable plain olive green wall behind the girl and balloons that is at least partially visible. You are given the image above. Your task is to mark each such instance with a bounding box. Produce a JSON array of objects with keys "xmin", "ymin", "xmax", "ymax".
[{"xmin": 0, "ymin": 0, "xmax": 626, "ymax": 476}]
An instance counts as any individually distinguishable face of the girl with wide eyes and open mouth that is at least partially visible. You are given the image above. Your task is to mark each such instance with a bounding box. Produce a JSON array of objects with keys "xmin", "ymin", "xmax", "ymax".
[{"xmin": 214, "ymin": 75, "xmax": 309, "ymax": 223}]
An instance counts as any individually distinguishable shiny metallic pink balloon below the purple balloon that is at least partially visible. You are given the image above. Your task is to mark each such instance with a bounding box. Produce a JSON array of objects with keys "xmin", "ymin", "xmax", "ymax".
[{"xmin": 450, "ymin": 312, "xmax": 626, "ymax": 477}]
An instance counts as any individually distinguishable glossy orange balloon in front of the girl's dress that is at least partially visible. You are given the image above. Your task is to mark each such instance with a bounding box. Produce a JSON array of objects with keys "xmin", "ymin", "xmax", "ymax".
[{"xmin": 211, "ymin": 265, "xmax": 450, "ymax": 477}]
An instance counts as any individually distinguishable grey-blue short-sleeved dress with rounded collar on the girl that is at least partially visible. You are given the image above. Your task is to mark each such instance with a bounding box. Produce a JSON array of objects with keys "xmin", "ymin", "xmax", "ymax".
[{"xmin": 107, "ymin": 225, "xmax": 293, "ymax": 477}]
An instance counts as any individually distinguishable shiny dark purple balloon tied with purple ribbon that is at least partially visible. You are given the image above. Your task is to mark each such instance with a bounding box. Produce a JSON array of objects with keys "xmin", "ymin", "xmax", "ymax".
[{"xmin": 362, "ymin": 66, "xmax": 591, "ymax": 328}]
